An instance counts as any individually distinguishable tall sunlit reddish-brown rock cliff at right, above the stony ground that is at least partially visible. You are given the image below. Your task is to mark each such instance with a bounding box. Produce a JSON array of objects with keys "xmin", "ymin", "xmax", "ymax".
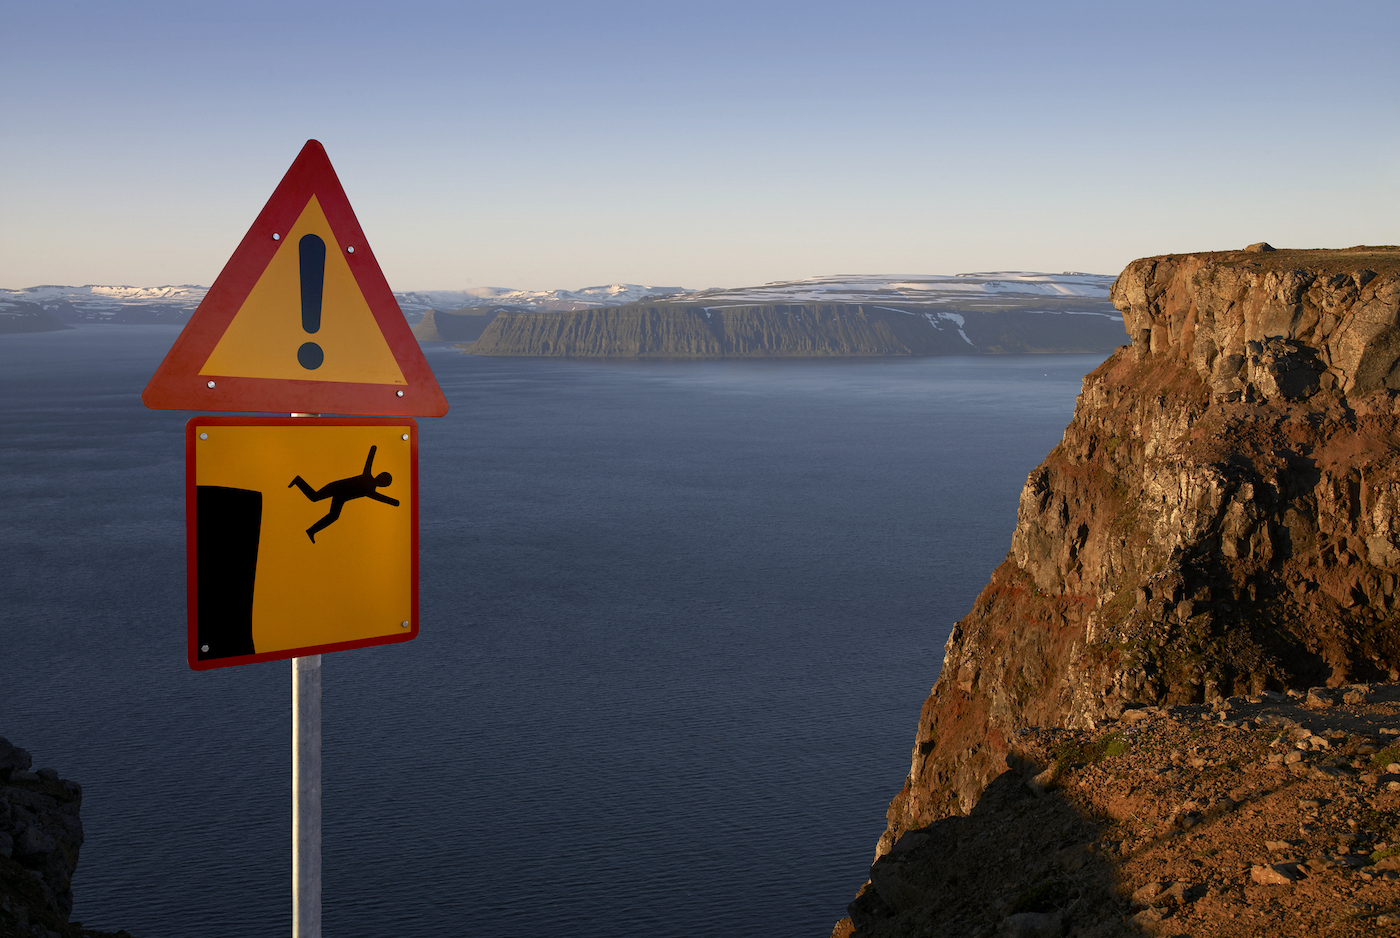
[{"xmin": 876, "ymin": 248, "xmax": 1400, "ymax": 855}]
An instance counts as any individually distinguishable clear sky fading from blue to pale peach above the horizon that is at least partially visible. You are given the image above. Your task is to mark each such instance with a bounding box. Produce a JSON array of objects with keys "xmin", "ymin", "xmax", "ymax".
[{"xmin": 0, "ymin": 0, "xmax": 1400, "ymax": 290}]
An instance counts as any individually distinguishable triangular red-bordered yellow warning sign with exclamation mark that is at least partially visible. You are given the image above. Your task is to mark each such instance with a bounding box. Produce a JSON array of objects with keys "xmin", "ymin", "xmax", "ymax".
[{"xmin": 141, "ymin": 140, "xmax": 447, "ymax": 417}]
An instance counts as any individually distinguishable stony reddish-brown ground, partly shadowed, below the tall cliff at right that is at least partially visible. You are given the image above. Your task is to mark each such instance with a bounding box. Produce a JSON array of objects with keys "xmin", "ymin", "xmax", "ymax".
[{"xmin": 833, "ymin": 685, "xmax": 1400, "ymax": 938}]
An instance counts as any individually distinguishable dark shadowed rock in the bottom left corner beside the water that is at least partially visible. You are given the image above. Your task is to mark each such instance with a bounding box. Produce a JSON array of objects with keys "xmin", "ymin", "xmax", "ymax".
[{"xmin": 0, "ymin": 738, "xmax": 130, "ymax": 938}]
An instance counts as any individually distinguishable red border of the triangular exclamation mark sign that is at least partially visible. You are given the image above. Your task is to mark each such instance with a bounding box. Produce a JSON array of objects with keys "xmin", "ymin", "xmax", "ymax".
[{"xmin": 141, "ymin": 140, "xmax": 447, "ymax": 417}]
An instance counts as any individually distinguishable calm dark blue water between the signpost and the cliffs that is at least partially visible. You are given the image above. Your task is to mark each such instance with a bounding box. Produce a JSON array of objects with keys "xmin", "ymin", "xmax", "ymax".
[{"xmin": 0, "ymin": 326, "xmax": 1098, "ymax": 938}]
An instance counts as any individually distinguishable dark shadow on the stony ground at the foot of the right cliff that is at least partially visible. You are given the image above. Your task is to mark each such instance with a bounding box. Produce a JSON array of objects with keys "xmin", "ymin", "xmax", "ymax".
[{"xmin": 834, "ymin": 763, "xmax": 1142, "ymax": 938}]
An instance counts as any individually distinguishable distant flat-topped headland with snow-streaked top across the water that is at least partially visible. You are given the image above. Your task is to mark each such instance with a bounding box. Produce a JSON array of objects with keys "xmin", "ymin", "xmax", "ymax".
[{"xmin": 425, "ymin": 272, "xmax": 1123, "ymax": 358}]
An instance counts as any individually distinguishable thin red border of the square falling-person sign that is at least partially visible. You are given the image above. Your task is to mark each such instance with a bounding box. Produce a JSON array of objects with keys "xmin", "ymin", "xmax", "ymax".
[{"xmin": 185, "ymin": 417, "xmax": 419, "ymax": 671}]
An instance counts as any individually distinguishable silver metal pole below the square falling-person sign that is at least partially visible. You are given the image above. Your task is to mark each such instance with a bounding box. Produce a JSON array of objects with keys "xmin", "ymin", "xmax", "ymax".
[{"xmin": 291, "ymin": 655, "xmax": 321, "ymax": 938}]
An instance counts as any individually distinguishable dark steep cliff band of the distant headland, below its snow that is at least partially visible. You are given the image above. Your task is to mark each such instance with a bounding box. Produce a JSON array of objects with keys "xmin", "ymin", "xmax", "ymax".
[{"xmin": 462, "ymin": 303, "xmax": 1121, "ymax": 358}]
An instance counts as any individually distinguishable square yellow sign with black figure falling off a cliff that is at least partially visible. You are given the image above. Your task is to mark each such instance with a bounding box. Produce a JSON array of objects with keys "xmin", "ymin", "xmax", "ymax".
[{"xmin": 186, "ymin": 417, "xmax": 419, "ymax": 671}]
